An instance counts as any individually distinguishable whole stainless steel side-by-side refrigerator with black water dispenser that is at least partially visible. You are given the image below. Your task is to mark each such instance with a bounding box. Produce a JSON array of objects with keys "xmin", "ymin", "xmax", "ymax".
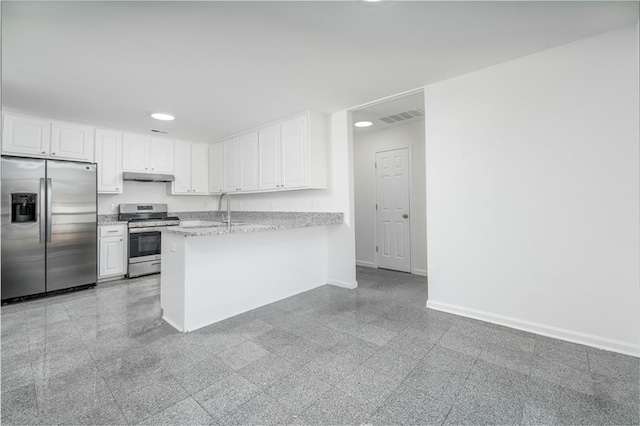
[{"xmin": 1, "ymin": 157, "xmax": 97, "ymax": 300}]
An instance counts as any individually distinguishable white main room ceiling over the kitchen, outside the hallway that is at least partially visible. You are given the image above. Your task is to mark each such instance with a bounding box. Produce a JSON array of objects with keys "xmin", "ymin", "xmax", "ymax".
[{"xmin": 1, "ymin": 1, "xmax": 638, "ymax": 141}]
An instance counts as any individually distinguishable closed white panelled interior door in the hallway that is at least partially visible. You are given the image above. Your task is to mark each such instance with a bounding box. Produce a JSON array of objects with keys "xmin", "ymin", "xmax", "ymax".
[{"xmin": 376, "ymin": 148, "xmax": 411, "ymax": 272}]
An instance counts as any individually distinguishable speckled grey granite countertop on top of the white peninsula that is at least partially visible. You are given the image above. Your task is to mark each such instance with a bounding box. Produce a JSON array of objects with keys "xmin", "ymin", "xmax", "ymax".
[{"xmin": 163, "ymin": 212, "xmax": 344, "ymax": 237}]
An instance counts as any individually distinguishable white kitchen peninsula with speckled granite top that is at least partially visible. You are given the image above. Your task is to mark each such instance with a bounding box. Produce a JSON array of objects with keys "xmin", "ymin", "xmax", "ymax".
[{"xmin": 160, "ymin": 212, "xmax": 343, "ymax": 332}]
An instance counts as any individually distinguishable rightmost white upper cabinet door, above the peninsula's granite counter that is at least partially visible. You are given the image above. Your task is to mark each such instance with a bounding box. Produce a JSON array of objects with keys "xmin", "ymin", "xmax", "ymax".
[{"xmin": 280, "ymin": 115, "xmax": 309, "ymax": 188}]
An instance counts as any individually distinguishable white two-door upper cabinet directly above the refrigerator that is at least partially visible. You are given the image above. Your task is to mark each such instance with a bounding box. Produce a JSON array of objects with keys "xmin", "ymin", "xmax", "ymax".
[{"xmin": 2, "ymin": 114, "xmax": 95, "ymax": 162}]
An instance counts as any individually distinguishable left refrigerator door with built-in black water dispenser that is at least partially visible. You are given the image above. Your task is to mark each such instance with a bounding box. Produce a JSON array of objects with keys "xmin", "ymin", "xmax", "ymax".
[{"xmin": 0, "ymin": 157, "xmax": 46, "ymax": 300}]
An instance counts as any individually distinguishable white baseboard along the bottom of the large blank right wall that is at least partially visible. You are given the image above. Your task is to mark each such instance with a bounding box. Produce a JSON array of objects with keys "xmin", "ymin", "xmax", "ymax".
[{"xmin": 427, "ymin": 300, "xmax": 640, "ymax": 356}]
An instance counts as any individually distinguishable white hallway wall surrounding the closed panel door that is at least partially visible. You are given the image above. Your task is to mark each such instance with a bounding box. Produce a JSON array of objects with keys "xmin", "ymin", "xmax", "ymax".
[{"xmin": 353, "ymin": 120, "xmax": 427, "ymax": 275}]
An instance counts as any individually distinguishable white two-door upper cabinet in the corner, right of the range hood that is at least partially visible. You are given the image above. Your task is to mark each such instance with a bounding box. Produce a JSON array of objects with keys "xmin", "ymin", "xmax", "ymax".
[{"xmin": 171, "ymin": 141, "xmax": 209, "ymax": 195}]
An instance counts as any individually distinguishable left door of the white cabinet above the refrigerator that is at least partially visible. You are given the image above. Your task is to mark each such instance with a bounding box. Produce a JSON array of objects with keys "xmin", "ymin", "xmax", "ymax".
[{"xmin": 2, "ymin": 114, "xmax": 51, "ymax": 157}]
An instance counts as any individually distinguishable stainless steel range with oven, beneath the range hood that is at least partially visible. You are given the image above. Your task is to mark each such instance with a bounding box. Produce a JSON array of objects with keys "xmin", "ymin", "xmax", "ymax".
[{"xmin": 118, "ymin": 204, "xmax": 180, "ymax": 278}]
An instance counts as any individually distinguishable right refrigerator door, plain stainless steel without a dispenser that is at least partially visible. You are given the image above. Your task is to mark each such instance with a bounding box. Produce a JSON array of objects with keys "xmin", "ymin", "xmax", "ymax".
[{"xmin": 47, "ymin": 160, "xmax": 98, "ymax": 291}]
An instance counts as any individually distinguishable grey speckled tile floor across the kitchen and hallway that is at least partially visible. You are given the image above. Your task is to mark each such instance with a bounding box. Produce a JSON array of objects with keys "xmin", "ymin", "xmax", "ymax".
[{"xmin": 1, "ymin": 268, "xmax": 640, "ymax": 425}]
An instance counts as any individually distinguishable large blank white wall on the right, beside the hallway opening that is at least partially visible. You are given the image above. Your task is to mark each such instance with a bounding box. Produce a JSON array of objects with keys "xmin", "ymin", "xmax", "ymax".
[{"xmin": 425, "ymin": 26, "xmax": 640, "ymax": 355}]
